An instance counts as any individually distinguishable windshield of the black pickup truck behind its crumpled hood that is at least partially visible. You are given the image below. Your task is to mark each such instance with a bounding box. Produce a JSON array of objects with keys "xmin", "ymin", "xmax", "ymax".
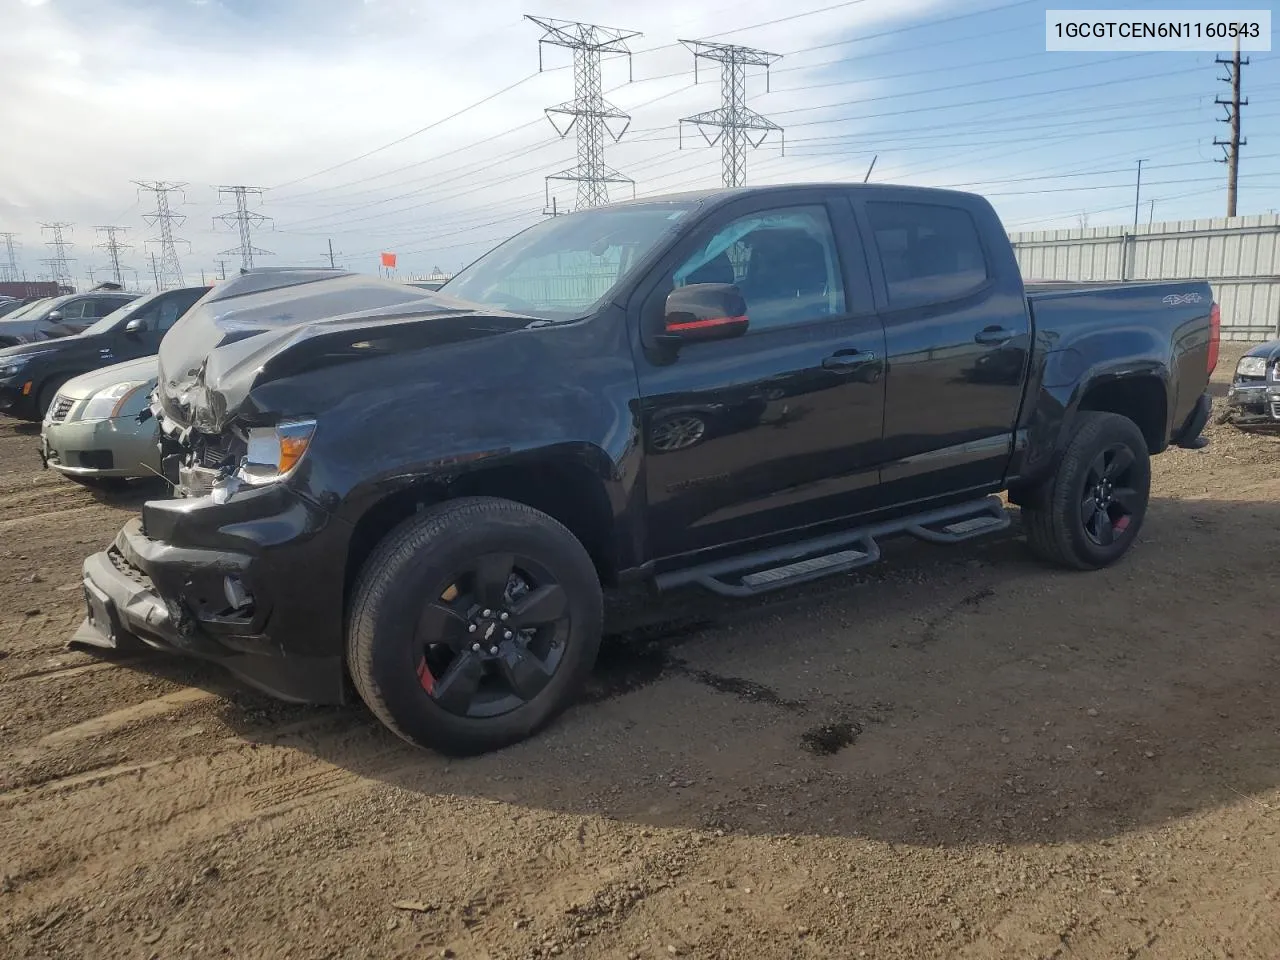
[{"xmin": 440, "ymin": 202, "xmax": 694, "ymax": 320}]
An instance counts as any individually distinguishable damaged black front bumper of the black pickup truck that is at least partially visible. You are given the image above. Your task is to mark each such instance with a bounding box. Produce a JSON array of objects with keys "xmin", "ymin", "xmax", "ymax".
[{"xmin": 72, "ymin": 486, "xmax": 349, "ymax": 704}]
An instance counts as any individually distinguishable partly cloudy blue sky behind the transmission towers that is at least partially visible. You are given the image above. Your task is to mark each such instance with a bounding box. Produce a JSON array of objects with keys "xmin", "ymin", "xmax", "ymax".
[{"xmin": 0, "ymin": 0, "xmax": 1280, "ymax": 289}]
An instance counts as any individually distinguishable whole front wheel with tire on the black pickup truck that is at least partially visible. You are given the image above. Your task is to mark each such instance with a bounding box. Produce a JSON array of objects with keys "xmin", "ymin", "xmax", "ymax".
[{"xmin": 347, "ymin": 497, "xmax": 603, "ymax": 754}]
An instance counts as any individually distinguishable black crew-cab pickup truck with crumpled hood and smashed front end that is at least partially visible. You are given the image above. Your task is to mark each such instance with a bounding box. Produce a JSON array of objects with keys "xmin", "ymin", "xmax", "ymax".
[{"xmin": 74, "ymin": 184, "xmax": 1219, "ymax": 751}]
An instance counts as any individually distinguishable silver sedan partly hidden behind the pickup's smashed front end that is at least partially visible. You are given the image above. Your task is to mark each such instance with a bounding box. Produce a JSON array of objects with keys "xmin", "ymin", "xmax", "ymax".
[{"xmin": 40, "ymin": 357, "xmax": 160, "ymax": 486}]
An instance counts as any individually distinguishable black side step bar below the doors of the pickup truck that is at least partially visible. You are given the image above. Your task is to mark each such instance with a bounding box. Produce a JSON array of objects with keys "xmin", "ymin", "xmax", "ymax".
[{"xmin": 655, "ymin": 497, "xmax": 1011, "ymax": 596}]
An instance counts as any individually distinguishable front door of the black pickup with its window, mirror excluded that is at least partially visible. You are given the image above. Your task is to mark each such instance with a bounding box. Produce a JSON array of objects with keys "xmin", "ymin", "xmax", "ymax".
[{"xmin": 631, "ymin": 189, "xmax": 884, "ymax": 558}]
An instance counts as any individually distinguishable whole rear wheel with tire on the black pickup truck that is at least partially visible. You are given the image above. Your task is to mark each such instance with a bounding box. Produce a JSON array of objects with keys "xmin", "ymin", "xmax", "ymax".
[{"xmin": 1023, "ymin": 411, "xmax": 1151, "ymax": 570}]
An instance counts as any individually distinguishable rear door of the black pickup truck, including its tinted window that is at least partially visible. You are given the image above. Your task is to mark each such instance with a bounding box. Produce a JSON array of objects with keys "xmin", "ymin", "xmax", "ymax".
[{"xmin": 852, "ymin": 197, "xmax": 1030, "ymax": 506}]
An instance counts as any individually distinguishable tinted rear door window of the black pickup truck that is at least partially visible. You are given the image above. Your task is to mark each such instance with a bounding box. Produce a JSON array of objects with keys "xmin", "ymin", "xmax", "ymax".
[{"xmin": 867, "ymin": 204, "xmax": 988, "ymax": 307}]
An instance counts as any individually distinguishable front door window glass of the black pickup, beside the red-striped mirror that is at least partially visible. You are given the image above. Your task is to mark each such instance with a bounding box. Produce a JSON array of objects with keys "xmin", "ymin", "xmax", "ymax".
[{"xmin": 672, "ymin": 206, "xmax": 846, "ymax": 332}]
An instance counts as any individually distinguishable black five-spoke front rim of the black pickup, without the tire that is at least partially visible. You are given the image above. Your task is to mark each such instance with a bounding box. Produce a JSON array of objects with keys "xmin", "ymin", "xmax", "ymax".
[{"xmin": 415, "ymin": 553, "xmax": 571, "ymax": 717}]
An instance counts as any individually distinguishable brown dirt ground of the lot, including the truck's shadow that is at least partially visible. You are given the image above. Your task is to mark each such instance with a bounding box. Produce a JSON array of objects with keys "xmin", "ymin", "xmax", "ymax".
[{"xmin": 0, "ymin": 344, "xmax": 1280, "ymax": 960}]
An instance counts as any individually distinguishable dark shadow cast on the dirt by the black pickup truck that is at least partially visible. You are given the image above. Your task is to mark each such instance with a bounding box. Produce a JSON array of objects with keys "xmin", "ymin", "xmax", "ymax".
[{"xmin": 97, "ymin": 499, "xmax": 1280, "ymax": 845}]
